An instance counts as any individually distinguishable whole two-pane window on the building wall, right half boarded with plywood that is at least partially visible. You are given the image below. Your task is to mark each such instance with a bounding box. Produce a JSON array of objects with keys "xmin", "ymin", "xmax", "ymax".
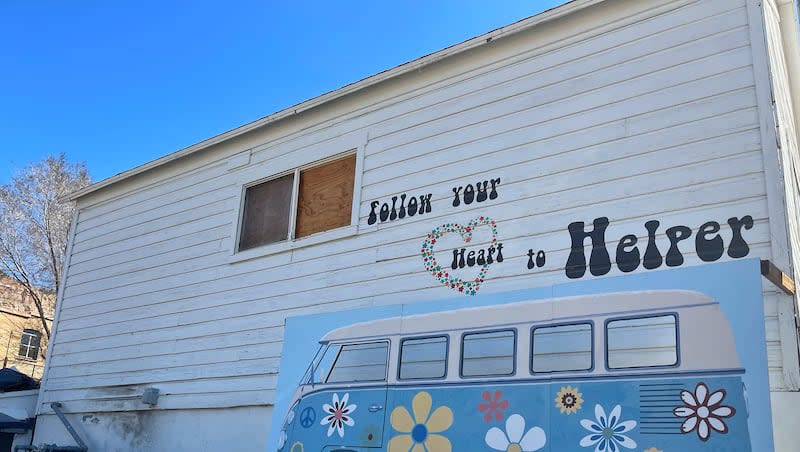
[{"xmin": 238, "ymin": 154, "xmax": 356, "ymax": 251}]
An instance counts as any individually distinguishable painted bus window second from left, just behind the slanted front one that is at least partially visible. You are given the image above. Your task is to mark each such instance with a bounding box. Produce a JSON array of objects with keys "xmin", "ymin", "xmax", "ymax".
[{"xmin": 400, "ymin": 336, "xmax": 447, "ymax": 380}]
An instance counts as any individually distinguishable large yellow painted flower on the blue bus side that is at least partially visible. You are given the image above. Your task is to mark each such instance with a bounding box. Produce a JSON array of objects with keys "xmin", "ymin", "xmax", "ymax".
[{"xmin": 389, "ymin": 391, "xmax": 453, "ymax": 452}]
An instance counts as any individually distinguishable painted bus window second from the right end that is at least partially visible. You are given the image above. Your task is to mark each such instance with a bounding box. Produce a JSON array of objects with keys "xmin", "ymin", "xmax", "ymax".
[{"xmin": 531, "ymin": 323, "xmax": 594, "ymax": 373}]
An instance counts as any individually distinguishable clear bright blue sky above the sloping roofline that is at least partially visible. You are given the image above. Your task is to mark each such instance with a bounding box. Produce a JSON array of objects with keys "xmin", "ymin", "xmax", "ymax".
[{"xmin": 0, "ymin": 0, "xmax": 565, "ymax": 183}]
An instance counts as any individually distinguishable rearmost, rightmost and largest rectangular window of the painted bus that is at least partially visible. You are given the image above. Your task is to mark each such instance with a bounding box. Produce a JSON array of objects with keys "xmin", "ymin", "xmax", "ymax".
[{"xmin": 606, "ymin": 315, "xmax": 678, "ymax": 369}]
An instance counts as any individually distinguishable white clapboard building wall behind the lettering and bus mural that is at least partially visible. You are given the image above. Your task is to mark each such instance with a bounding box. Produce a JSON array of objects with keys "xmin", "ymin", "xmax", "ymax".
[{"xmin": 39, "ymin": 0, "xmax": 798, "ymax": 420}]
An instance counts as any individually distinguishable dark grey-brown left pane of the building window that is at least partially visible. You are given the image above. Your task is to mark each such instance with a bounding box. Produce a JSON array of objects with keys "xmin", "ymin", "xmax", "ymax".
[{"xmin": 239, "ymin": 174, "xmax": 294, "ymax": 251}]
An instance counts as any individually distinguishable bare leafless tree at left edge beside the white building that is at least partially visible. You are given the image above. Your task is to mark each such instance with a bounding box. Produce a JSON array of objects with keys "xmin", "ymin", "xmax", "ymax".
[{"xmin": 0, "ymin": 153, "xmax": 91, "ymax": 339}]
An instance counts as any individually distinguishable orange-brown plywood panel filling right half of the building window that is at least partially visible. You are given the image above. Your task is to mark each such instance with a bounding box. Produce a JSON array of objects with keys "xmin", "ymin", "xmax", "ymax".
[{"xmin": 295, "ymin": 155, "xmax": 356, "ymax": 237}]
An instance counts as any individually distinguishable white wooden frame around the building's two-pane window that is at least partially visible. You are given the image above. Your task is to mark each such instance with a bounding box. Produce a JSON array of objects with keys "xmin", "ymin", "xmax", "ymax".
[{"xmin": 228, "ymin": 139, "xmax": 367, "ymax": 264}]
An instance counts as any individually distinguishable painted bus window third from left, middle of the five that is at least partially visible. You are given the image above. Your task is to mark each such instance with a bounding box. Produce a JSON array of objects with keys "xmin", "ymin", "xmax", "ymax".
[{"xmin": 461, "ymin": 330, "xmax": 516, "ymax": 377}]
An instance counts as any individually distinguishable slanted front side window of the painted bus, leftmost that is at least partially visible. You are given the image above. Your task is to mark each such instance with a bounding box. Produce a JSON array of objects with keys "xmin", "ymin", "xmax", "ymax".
[{"xmin": 320, "ymin": 342, "xmax": 389, "ymax": 383}]
